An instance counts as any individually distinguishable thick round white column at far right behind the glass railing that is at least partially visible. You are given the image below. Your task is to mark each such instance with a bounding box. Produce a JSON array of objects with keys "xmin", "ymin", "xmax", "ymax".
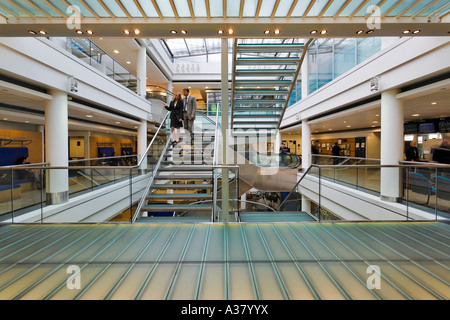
[{"xmin": 380, "ymin": 89, "xmax": 403, "ymax": 201}]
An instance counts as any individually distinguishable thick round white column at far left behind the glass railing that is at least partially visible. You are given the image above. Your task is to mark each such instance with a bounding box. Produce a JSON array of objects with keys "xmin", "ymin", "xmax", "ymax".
[{"xmin": 45, "ymin": 90, "xmax": 69, "ymax": 204}]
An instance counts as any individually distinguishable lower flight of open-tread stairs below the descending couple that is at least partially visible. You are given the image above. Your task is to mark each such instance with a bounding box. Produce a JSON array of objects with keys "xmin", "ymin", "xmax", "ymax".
[{"xmin": 137, "ymin": 133, "xmax": 213, "ymax": 223}]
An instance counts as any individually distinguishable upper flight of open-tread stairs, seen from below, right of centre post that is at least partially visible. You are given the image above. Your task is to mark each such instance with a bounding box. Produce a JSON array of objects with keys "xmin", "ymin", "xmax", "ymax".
[{"xmin": 231, "ymin": 39, "xmax": 311, "ymax": 134}]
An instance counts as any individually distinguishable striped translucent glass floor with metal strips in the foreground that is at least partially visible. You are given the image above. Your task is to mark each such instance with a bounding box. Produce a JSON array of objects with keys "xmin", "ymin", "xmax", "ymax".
[{"xmin": 0, "ymin": 222, "xmax": 450, "ymax": 300}]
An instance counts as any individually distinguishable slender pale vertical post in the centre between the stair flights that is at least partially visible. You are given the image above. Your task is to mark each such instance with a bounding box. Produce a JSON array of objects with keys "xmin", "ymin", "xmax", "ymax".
[{"xmin": 221, "ymin": 38, "xmax": 229, "ymax": 222}]
